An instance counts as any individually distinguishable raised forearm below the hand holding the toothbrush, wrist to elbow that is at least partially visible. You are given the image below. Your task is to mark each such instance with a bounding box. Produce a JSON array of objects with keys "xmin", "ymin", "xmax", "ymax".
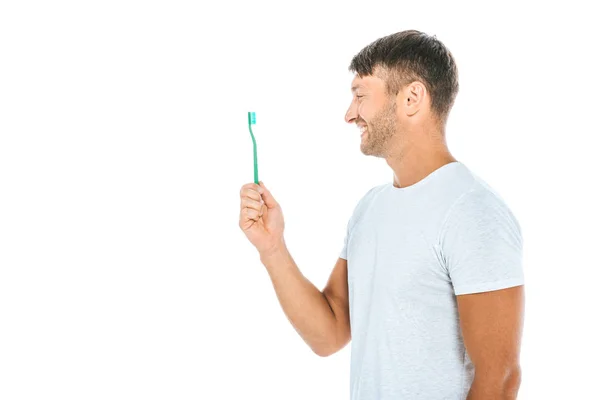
[{"xmin": 261, "ymin": 245, "xmax": 336, "ymax": 356}]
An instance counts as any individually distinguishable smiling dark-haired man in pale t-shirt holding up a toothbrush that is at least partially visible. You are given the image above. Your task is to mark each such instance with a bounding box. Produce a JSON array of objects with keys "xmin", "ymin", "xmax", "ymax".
[{"xmin": 240, "ymin": 30, "xmax": 524, "ymax": 400}]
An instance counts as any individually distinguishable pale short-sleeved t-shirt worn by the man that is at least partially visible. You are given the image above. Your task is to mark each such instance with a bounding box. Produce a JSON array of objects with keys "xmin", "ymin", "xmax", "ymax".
[{"xmin": 340, "ymin": 161, "xmax": 524, "ymax": 400}]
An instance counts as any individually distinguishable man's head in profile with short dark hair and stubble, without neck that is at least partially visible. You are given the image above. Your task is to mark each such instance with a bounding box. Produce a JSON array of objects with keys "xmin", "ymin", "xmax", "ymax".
[{"xmin": 346, "ymin": 30, "xmax": 458, "ymax": 157}]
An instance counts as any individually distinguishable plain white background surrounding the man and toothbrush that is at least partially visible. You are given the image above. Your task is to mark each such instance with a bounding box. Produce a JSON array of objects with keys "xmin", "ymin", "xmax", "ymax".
[{"xmin": 0, "ymin": 1, "xmax": 600, "ymax": 400}]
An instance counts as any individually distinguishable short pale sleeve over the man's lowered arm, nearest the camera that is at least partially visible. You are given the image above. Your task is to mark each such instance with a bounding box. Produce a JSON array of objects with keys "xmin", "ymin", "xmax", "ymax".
[{"xmin": 438, "ymin": 188, "xmax": 524, "ymax": 295}]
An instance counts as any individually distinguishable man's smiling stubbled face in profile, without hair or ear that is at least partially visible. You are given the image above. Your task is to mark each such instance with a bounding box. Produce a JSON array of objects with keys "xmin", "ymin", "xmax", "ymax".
[{"xmin": 346, "ymin": 75, "xmax": 397, "ymax": 157}]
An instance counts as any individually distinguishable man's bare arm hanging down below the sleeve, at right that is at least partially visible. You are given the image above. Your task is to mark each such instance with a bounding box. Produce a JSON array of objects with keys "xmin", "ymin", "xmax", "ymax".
[{"xmin": 457, "ymin": 285, "xmax": 525, "ymax": 400}]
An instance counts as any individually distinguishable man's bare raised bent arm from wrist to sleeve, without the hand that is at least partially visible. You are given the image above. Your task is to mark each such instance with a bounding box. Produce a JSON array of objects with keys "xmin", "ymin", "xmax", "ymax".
[{"xmin": 261, "ymin": 245, "xmax": 350, "ymax": 357}]
